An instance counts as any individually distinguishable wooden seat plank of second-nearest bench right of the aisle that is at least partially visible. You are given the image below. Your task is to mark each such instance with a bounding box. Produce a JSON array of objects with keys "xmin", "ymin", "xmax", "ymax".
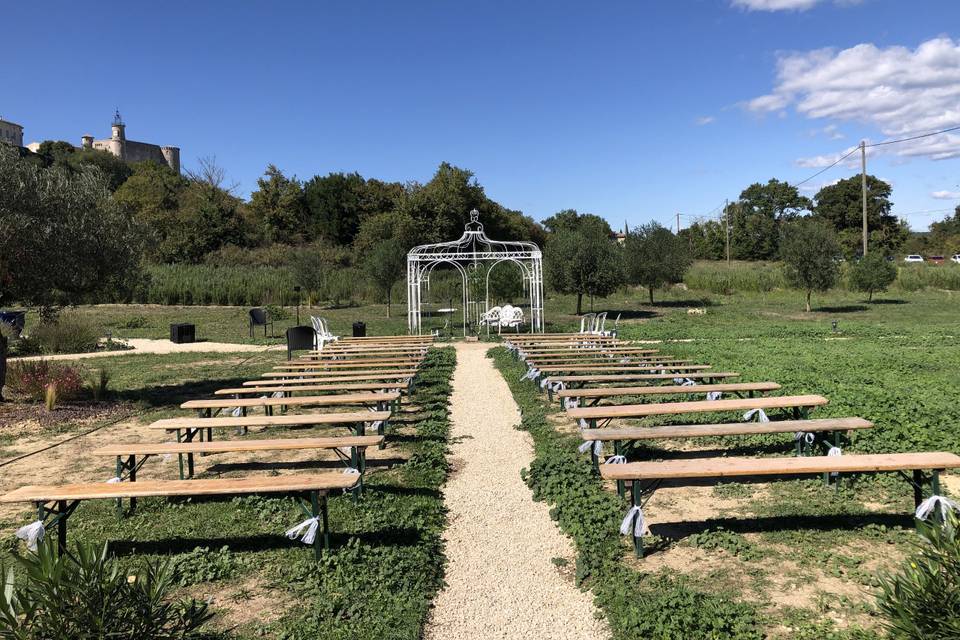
[{"xmin": 580, "ymin": 418, "xmax": 873, "ymax": 441}]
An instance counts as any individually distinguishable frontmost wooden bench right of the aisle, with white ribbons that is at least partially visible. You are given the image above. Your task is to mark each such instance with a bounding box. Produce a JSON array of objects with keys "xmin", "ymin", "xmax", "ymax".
[{"xmin": 600, "ymin": 452, "xmax": 960, "ymax": 557}]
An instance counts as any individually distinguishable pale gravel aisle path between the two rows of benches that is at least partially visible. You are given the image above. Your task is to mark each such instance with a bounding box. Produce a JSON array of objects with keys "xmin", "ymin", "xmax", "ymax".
[{"xmin": 425, "ymin": 343, "xmax": 609, "ymax": 640}]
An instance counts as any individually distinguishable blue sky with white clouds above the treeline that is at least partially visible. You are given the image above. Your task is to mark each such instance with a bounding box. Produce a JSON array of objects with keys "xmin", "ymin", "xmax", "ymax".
[{"xmin": 0, "ymin": 0, "xmax": 960, "ymax": 229}]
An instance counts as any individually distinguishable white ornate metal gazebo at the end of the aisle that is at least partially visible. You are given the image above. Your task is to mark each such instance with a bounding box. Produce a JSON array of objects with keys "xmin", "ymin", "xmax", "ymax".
[{"xmin": 407, "ymin": 209, "xmax": 543, "ymax": 336}]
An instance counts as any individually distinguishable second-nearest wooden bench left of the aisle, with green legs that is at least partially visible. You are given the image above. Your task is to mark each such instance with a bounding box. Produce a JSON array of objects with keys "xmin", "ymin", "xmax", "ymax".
[{"xmin": 93, "ymin": 436, "xmax": 383, "ymax": 490}]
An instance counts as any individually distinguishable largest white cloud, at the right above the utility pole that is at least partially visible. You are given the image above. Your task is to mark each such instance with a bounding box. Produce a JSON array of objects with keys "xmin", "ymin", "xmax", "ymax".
[{"xmin": 746, "ymin": 37, "xmax": 960, "ymax": 160}]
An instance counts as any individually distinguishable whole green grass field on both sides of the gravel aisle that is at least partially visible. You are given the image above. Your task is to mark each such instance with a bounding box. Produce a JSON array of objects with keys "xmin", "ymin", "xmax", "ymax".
[{"xmin": 0, "ymin": 288, "xmax": 960, "ymax": 640}]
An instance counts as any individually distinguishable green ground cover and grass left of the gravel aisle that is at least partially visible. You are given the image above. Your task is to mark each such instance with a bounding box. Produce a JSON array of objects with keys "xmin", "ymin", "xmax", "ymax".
[{"xmin": 0, "ymin": 349, "xmax": 455, "ymax": 640}]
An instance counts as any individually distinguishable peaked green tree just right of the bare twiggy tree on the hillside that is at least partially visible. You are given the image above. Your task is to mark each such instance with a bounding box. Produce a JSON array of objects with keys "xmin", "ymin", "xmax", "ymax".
[{"xmin": 250, "ymin": 164, "xmax": 306, "ymax": 242}]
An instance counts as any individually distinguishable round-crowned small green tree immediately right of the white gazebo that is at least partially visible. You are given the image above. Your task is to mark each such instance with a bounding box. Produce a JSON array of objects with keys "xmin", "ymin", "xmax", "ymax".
[{"xmin": 544, "ymin": 227, "xmax": 623, "ymax": 315}]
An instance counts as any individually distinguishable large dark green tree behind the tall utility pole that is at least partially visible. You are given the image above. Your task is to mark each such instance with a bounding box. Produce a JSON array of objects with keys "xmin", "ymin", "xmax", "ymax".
[{"xmin": 813, "ymin": 175, "xmax": 909, "ymax": 257}]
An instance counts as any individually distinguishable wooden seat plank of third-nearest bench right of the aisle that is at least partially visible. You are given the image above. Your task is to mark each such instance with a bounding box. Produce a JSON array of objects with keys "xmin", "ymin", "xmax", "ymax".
[{"xmin": 567, "ymin": 395, "xmax": 828, "ymax": 420}]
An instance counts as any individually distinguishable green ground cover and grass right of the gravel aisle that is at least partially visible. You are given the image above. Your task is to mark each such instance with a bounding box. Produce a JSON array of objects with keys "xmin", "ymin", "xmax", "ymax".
[{"xmin": 495, "ymin": 291, "xmax": 960, "ymax": 639}]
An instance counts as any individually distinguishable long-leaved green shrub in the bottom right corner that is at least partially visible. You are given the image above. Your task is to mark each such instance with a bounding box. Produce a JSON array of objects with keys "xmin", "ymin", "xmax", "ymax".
[{"xmin": 877, "ymin": 513, "xmax": 960, "ymax": 640}]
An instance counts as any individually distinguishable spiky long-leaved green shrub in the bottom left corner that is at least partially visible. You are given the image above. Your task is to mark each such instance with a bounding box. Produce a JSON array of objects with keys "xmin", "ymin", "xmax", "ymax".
[{"xmin": 0, "ymin": 539, "xmax": 212, "ymax": 640}]
